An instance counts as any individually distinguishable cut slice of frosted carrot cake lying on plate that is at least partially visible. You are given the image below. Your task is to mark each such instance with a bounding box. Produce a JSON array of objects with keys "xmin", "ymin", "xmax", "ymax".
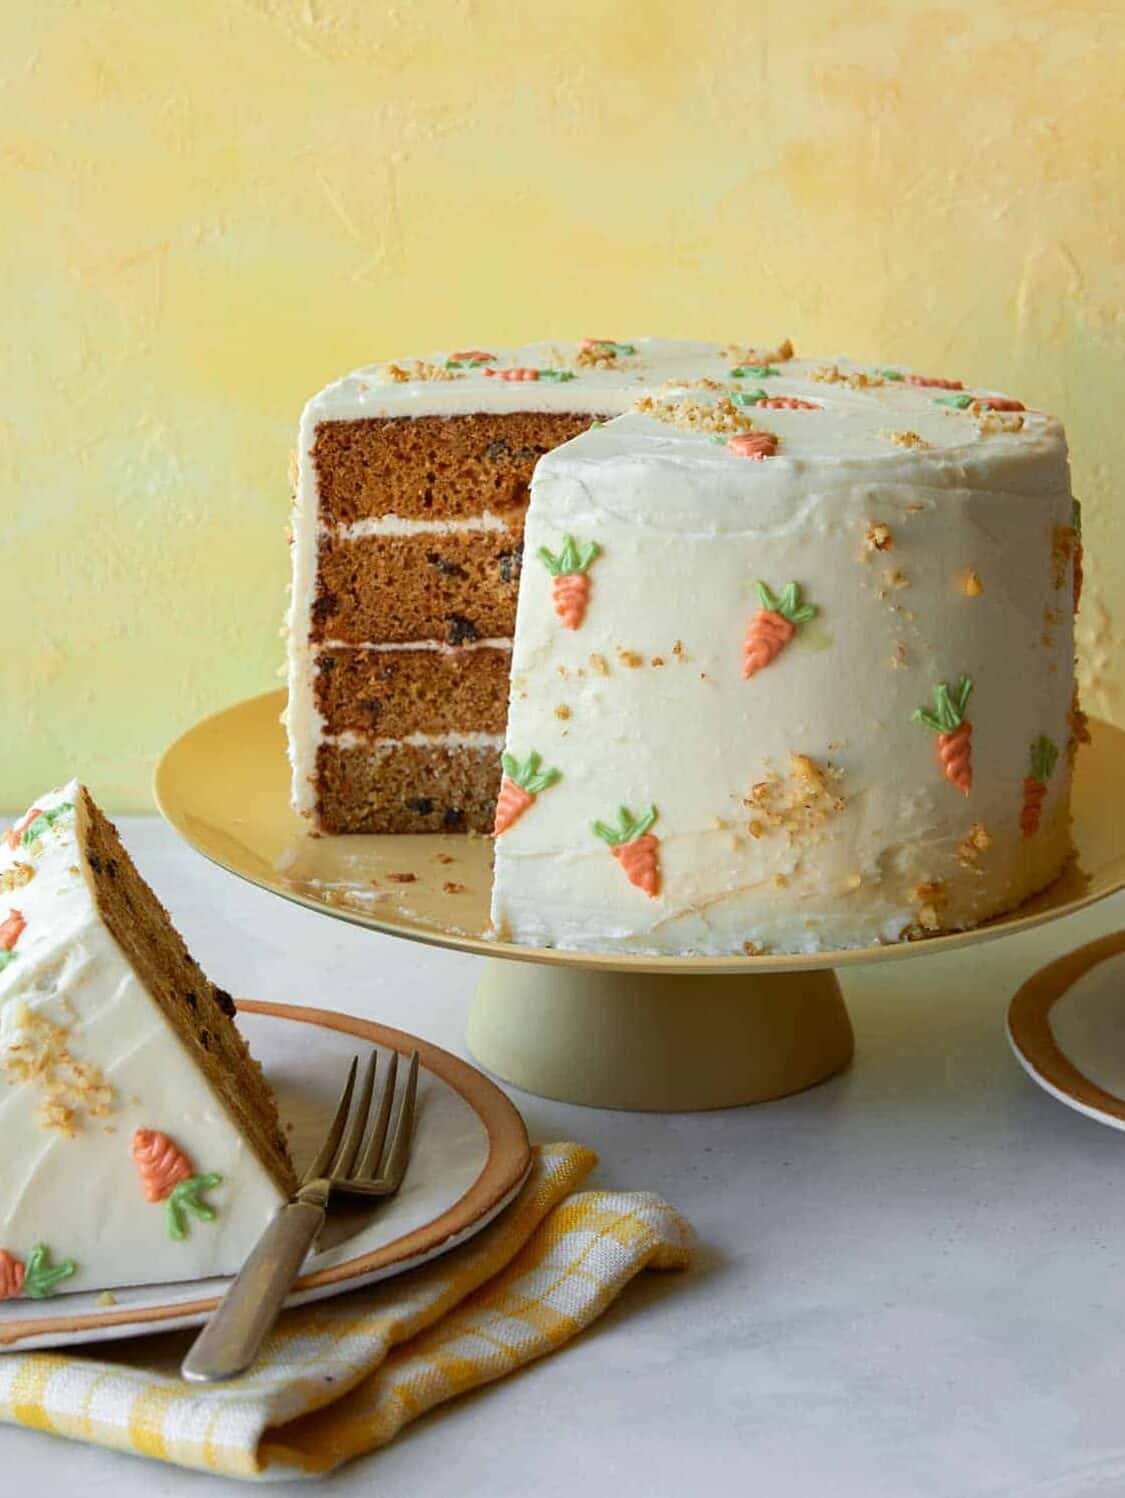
[{"xmin": 0, "ymin": 780, "xmax": 294, "ymax": 1299}]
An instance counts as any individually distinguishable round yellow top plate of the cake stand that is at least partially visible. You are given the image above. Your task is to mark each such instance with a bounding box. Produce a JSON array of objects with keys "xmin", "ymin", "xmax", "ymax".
[{"xmin": 154, "ymin": 691, "xmax": 1125, "ymax": 975}]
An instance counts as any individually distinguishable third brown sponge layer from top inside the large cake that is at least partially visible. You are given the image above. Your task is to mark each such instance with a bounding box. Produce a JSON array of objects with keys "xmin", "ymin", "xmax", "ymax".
[{"xmin": 316, "ymin": 644, "xmax": 511, "ymax": 739}]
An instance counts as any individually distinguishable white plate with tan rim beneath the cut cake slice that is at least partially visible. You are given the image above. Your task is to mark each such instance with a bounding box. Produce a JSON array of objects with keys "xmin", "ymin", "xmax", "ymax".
[{"xmin": 0, "ymin": 1002, "xmax": 532, "ymax": 1351}]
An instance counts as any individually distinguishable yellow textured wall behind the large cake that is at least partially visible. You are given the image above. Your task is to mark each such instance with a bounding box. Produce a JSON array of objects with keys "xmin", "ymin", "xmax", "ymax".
[{"xmin": 0, "ymin": 0, "xmax": 1125, "ymax": 810}]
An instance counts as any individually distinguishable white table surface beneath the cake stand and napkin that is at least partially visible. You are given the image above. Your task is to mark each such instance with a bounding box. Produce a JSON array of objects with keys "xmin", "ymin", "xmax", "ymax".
[{"xmin": 0, "ymin": 818, "xmax": 1125, "ymax": 1498}]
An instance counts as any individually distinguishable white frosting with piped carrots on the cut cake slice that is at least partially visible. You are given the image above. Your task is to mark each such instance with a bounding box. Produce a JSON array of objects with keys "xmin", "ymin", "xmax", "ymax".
[{"xmin": 0, "ymin": 782, "xmax": 283, "ymax": 1294}]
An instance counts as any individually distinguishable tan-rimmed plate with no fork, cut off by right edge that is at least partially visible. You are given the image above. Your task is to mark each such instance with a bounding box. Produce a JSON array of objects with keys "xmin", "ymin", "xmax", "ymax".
[{"xmin": 1008, "ymin": 932, "xmax": 1125, "ymax": 1129}]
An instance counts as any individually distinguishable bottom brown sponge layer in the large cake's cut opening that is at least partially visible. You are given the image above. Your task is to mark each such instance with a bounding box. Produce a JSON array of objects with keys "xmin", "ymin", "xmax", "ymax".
[{"xmin": 316, "ymin": 737, "xmax": 502, "ymax": 833}]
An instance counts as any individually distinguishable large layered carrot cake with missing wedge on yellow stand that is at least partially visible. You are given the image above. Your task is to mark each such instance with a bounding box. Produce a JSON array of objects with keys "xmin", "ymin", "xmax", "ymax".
[{"xmin": 288, "ymin": 339, "xmax": 1082, "ymax": 954}]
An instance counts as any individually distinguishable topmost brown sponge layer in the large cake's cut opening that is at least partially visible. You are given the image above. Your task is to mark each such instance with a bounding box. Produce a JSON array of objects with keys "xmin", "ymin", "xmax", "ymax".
[{"xmin": 312, "ymin": 410, "xmax": 602, "ymax": 524}]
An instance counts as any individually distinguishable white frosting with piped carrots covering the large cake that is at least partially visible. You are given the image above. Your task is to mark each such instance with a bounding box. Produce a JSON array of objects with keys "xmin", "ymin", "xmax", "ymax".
[{"xmin": 288, "ymin": 339, "xmax": 1077, "ymax": 954}]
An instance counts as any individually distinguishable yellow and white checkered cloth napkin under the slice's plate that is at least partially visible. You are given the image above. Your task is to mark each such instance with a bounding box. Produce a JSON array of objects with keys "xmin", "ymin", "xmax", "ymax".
[{"xmin": 0, "ymin": 1144, "xmax": 691, "ymax": 1479}]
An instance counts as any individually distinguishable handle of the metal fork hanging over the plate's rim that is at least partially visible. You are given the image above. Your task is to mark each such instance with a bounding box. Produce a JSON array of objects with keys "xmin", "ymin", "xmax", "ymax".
[{"xmin": 180, "ymin": 1200, "xmax": 325, "ymax": 1384}]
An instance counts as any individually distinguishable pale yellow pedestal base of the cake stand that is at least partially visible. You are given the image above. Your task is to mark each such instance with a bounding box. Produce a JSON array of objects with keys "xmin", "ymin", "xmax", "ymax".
[{"xmin": 467, "ymin": 959, "xmax": 854, "ymax": 1112}]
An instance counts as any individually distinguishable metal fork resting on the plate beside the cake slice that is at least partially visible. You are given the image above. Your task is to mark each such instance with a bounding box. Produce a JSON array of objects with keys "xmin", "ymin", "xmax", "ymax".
[{"xmin": 180, "ymin": 1052, "xmax": 418, "ymax": 1384}]
